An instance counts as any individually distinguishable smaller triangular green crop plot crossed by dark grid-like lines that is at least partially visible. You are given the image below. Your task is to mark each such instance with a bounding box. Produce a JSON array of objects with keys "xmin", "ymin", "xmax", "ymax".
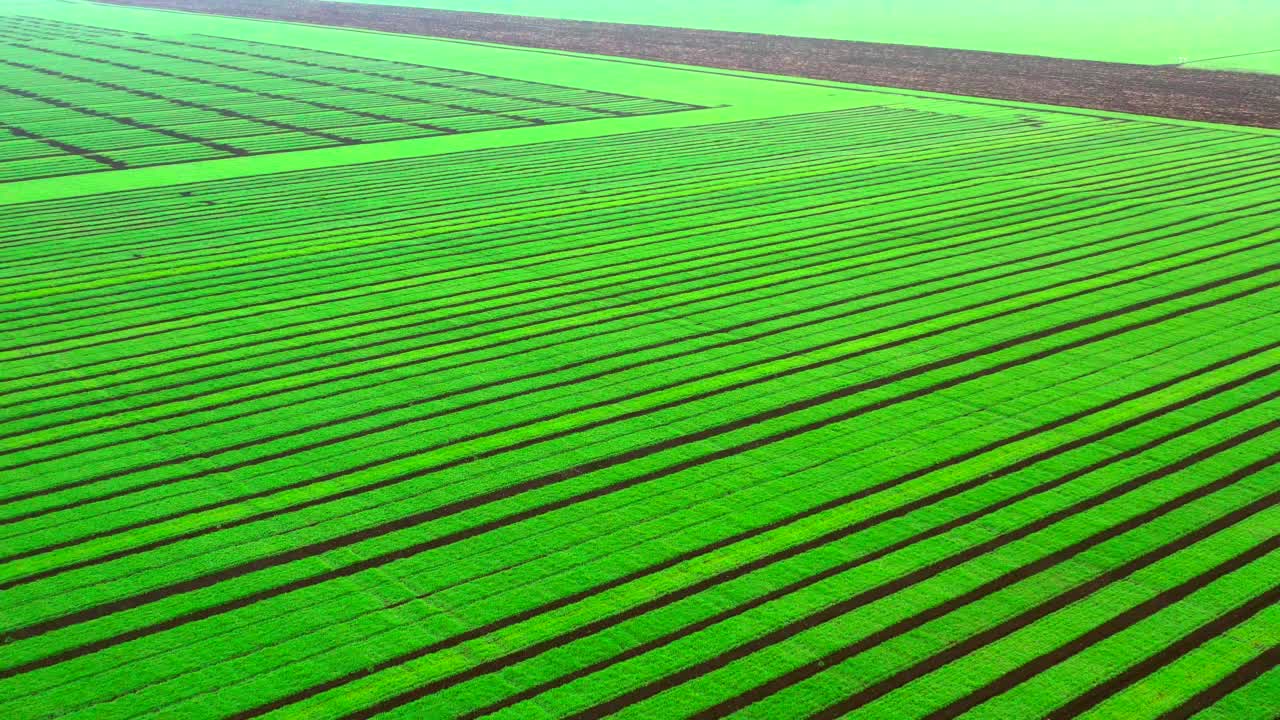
[{"xmin": 0, "ymin": 15, "xmax": 694, "ymax": 182}]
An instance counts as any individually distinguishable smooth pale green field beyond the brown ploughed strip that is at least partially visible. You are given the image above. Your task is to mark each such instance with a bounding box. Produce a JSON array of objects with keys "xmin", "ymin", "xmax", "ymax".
[{"xmin": 340, "ymin": 0, "xmax": 1280, "ymax": 73}]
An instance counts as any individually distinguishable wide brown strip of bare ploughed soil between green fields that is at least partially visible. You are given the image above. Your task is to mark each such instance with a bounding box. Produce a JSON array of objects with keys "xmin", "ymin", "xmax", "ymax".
[{"xmin": 90, "ymin": 0, "xmax": 1280, "ymax": 128}]
